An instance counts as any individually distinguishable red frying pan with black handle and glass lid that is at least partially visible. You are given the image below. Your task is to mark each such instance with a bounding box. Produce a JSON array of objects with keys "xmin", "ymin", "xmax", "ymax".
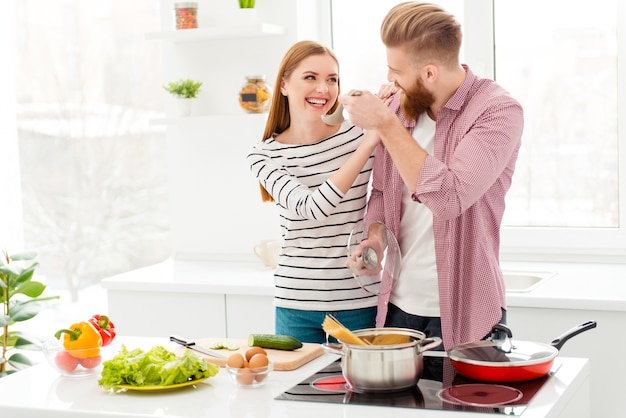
[{"xmin": 448, "ymin": 321, "xmax": 596, "ymax": 382}]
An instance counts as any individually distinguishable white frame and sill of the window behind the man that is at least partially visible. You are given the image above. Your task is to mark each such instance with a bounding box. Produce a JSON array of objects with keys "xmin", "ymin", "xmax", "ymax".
[{"xmin": 321, "ymin": 0, "xmax": 626, "ymax": 263}]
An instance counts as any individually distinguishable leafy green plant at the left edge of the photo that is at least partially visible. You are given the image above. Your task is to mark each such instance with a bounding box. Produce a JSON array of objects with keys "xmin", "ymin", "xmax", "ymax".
[{"xmin": 0, "ymin": 250, "xmax": 59, "ymax": 378}]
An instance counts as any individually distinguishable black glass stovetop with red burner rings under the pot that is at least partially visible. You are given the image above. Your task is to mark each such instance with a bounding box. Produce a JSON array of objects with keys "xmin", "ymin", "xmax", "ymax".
[{"xmin": 276, "ymin": 356, "xmax": 549, "ymax": 416}]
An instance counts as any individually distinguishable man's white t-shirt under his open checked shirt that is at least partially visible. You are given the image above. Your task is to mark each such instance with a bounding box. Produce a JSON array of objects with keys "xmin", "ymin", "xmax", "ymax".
[{"xmin": 391, "ymin": 115, "xmax": 440, "ymax": 317}]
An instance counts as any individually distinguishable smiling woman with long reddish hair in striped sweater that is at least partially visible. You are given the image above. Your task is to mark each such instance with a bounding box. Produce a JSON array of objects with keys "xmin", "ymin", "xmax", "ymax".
[{"xmin": 247, "ymin": 41, "xmax": 378, "ymax": 343}]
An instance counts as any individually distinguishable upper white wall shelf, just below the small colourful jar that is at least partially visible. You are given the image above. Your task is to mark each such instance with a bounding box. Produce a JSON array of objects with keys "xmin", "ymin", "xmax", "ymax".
[{"xmin": 146, "ymin": 23, "xmax": 285, "ymax": 42}]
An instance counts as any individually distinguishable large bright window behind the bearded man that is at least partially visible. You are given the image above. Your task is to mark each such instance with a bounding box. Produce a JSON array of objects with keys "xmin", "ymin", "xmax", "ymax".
[{"xmin": 331, "ymin": 0, "xmax": 626, "ymax": 261}]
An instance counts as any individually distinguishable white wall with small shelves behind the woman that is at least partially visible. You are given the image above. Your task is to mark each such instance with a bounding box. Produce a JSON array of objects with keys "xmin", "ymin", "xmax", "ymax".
[{"xmin": 161, "ymin": 0, "xmax": 330, "ymax": 260}]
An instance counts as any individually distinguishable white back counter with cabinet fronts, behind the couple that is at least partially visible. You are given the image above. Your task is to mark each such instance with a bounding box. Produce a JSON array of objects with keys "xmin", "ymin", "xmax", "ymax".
[{"xmin": 102, "ymin": 259, "xmax": 626, "ymax": 416}]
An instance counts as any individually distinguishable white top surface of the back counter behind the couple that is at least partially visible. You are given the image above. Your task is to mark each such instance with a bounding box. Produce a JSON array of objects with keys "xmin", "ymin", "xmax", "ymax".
[{"xmin": 102, "ymin": 259, "xmax": 626, "ymax": 311}]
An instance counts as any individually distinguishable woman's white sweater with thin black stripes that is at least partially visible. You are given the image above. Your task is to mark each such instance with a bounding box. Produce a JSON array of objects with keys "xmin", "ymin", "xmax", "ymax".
[{"xmin": 247, "ymin": 121, "xmax": 376, "ymax": 311}]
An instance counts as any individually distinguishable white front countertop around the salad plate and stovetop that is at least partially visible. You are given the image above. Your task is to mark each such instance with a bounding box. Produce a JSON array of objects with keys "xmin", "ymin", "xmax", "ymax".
[{"xmin": 0, "ymin": 337, "xmax": 590, "ymax": 418}]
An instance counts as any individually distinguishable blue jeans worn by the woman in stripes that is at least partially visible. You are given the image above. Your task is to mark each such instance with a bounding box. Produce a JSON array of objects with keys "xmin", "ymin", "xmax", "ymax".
[{"xmin": 275, "ymin": 307, "xmax": 376, "ymax": 344}]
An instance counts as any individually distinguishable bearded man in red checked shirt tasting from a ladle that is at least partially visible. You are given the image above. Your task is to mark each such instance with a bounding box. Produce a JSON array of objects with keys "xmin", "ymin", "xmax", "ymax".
[{"xmin": 340, "ymin": 2, "xmax": 523, "ymax": 350}]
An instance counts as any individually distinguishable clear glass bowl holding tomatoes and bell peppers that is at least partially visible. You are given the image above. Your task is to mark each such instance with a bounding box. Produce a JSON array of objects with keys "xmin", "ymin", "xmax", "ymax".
[{"xmin": 42, "ymin": 340, "xmax": 117, "ymax": 377}]
